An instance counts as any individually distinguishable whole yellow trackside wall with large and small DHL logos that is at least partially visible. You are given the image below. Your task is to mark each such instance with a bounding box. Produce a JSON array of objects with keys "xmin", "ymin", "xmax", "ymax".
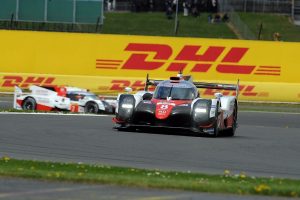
[{"xmin": 0, "ymin": 30, "xmax": 300, "ymax": 102}]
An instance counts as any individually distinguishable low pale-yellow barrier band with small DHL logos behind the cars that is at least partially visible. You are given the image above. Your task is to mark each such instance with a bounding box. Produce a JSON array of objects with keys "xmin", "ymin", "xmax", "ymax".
[{"xmin": 0, "ymin": 74, "xmax": 300, "ymax": 102}]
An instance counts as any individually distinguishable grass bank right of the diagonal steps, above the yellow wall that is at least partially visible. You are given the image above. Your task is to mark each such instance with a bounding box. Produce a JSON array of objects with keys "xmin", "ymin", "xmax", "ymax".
[{"xmin": 239, "ymin": 13, "xmax": 300, "ymax": 42}]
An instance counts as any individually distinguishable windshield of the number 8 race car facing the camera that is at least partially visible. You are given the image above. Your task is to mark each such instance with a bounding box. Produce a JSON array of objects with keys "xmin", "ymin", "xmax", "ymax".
[{"xmin": 154, "ymin": 86, "xmax": 195, "ymax": 100}]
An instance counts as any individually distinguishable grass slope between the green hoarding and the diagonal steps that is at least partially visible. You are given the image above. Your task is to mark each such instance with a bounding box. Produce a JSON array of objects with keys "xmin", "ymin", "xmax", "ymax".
[{"xmin": 101, "ymin": 12, "xmax": 236, "ymax": 38}]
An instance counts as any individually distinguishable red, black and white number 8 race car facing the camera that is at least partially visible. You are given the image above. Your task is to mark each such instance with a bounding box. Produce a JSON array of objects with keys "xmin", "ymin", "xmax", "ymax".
[{"xmin": 113, "ymin": 73, "xmax": 239, "ymax": 137}]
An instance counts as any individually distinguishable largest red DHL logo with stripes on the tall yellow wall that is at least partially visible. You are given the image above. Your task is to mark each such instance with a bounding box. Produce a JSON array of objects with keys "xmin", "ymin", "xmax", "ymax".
[{"xmin": 96, "ymin": 43, "xmax": 281, "ymax": 76}]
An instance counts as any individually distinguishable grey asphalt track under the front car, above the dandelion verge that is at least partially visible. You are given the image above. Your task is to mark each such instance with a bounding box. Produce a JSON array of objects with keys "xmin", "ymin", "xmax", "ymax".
[{"xmin": 0, "ymin": 112, "xmax": 300, "ymax": 179}]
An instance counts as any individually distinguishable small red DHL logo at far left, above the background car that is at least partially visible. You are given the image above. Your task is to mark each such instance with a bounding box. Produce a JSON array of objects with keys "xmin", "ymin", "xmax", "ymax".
[{"xmin": 1, "ymin": 76, "xmax": 55, "ymax": 88}]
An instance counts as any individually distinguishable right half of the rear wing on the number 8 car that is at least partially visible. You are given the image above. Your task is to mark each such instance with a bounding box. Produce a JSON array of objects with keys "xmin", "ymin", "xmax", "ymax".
[{"xmin": 193, "ymin": 79, "xmax": 240, "ymax": 99}]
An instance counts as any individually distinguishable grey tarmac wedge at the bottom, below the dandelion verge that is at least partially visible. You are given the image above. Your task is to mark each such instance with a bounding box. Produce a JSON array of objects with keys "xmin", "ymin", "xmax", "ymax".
[{"xmin": 0, "ymin": 178, "xmax": 288, "ymax": 200}]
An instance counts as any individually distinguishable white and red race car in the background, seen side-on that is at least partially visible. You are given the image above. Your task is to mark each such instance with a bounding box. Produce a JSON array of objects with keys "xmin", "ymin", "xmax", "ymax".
[{"xmin": 14, "ymin": 85, "xmax": 115, "ymax": 113}]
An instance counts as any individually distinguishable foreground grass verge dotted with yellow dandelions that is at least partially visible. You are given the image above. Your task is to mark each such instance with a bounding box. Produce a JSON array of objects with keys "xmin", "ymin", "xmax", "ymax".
[{"xmin": 0, "ymin": 157, "xmax": 300, "ymax": 197}]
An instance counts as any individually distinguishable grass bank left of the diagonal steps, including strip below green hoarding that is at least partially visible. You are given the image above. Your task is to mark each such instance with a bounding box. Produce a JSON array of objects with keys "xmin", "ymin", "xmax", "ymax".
[{"xmin": 0, "ymin": 12, "xmax": 237, "ymax": 38}]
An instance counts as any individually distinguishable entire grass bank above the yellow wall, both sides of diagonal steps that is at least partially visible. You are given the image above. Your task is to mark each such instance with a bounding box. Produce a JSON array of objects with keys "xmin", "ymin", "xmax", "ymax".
[{"xmin": 0, "ymin": 12, "xmax": 300, "ymax": 42}]
